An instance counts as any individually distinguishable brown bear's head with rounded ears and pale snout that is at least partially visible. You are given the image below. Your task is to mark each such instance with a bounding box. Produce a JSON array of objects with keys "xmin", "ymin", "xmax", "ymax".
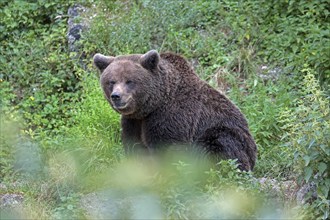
[{"xmin": 93, "ymin": 50, "xmax": 162, "ymax": 118}]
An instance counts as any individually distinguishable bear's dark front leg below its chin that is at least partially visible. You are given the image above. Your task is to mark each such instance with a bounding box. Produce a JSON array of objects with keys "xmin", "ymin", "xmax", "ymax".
[{"xmin": 121, "ymin": 116, "xmax": 148, "ymax": 156}]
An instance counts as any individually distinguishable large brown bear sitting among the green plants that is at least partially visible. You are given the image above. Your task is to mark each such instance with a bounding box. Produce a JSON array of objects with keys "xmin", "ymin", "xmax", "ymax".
[{"xmin": 93, "ymin": 50, "xmax": 257, "ymax": 171}]
